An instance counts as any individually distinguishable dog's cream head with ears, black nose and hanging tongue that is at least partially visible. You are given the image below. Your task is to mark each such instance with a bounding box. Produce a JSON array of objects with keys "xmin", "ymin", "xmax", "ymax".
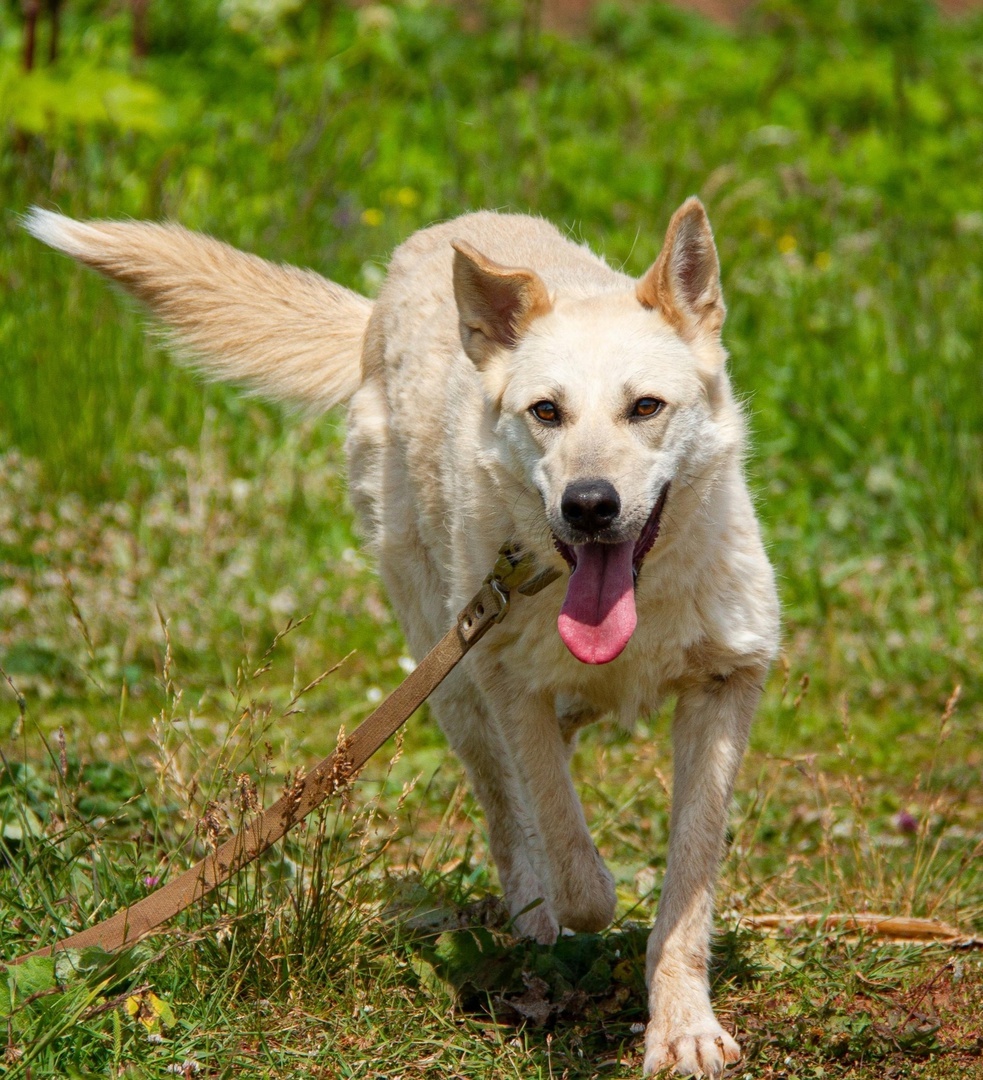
[{"xmin": 454, "ymin": 199, "xmax": 740, "ymax": 664}]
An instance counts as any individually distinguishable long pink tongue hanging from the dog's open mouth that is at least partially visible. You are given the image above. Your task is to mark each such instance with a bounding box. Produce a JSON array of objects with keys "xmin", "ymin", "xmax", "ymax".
[{"xmin": 556, "ymin": 540, "xmax": 637, "ymax": 664}]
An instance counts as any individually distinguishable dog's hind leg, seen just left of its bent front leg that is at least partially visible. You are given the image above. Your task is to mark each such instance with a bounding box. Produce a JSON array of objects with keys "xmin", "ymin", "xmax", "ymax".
[{"xmin": 431, "ymin": 673, "xmax": 560, "ymax": 945}]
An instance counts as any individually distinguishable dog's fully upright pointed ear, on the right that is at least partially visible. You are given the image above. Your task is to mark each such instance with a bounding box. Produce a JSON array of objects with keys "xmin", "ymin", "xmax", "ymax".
[{"xmin": 635, "ymin": 195, "xmax": 727, "ymax": 336}]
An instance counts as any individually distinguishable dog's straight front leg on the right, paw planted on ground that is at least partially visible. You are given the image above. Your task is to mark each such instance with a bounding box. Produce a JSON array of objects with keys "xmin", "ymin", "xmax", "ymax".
[{"xmin": 644, "ymin": 667, "xmax": 765, "ymax": 1077}]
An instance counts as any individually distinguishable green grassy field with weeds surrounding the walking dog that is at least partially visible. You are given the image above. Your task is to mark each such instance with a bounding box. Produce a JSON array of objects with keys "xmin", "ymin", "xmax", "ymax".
[{"xmin": 0, "ymin": 0, "xmax": 983, "ymax": 1080}]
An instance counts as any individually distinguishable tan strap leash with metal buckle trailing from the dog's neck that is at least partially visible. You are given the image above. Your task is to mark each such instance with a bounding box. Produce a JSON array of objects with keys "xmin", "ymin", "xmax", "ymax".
[{"xmin": 13, "ymin": 544, "xmax": 560, "ymax": 963}]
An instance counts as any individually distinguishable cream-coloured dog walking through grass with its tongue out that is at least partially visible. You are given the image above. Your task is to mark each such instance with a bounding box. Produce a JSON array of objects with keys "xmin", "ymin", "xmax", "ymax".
[{"xmin": 27, "ymin": 199, "xmax": 778, "ymax": 1077}]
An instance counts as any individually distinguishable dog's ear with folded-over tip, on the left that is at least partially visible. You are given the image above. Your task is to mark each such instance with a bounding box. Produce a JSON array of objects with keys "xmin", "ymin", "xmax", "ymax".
[{"xmin": 450, "ymin": 240, "xmax": 553, "ymax": 367}]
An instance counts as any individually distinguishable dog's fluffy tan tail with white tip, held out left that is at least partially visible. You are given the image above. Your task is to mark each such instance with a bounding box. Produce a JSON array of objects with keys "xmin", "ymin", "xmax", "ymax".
[{"xmin": 24, "ymin": 207, "xmax": 372, "ymax": 409}]
